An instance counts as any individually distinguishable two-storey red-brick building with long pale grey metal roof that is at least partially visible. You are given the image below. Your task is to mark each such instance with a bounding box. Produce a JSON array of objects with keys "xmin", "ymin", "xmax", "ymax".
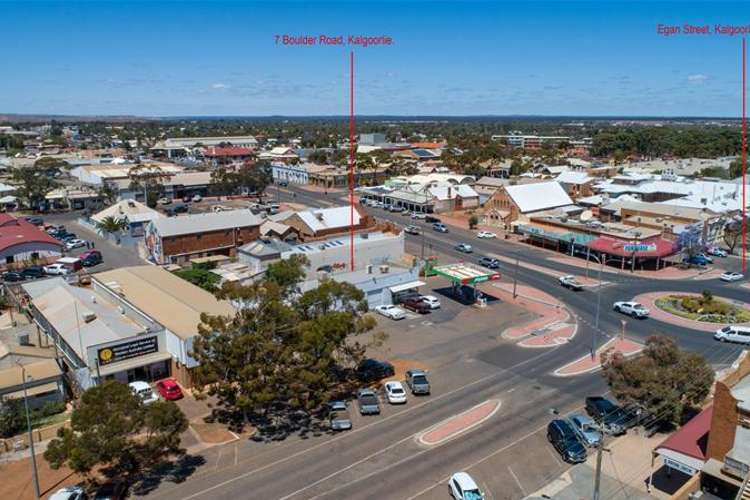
[{"xmin": 146, "ymin": 210, "xmax": 263, "ymax": 264}]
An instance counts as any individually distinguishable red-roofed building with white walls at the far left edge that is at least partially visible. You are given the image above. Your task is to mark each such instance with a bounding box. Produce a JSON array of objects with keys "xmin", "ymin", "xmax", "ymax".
[{"xmin": 0, "ymin": 213, "xmax": 62, "ymax": 264}]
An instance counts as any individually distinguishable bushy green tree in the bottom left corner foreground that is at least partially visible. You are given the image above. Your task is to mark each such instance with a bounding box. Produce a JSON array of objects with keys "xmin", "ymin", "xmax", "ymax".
[{"xmin": 44, "ymin": 380, "xmax": 188, "ymax": 484}]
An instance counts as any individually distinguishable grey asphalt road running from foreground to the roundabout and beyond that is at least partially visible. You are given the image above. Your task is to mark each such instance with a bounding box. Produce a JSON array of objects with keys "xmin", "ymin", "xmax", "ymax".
[{"xmin": 145, "ymin": 190, "xmax": 747, "ymax": 499}]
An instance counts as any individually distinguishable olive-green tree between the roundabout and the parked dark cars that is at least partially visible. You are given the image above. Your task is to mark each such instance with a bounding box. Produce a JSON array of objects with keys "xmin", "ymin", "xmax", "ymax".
[{"xmin": 602, "ymin": 336, "xmax": 714, "ymax": 423}]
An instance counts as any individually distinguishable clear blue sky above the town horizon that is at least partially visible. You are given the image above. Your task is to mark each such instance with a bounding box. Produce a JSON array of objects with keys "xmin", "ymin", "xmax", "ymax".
[{"xmin": 0, "ymin": 0, "xmax": 750, "ymax": 116}]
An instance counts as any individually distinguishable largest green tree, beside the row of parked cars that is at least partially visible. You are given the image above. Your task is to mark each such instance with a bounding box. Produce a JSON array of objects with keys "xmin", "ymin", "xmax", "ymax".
[{"xmin": 192, "ymin": 260, "xmax": 382, "ymax": 434}]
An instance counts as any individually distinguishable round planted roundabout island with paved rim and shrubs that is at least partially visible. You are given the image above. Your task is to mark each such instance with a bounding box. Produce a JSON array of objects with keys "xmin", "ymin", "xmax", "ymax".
[{"xmin": 633, "ymin": 292, "xmax": 750, "ymax": 332}]
